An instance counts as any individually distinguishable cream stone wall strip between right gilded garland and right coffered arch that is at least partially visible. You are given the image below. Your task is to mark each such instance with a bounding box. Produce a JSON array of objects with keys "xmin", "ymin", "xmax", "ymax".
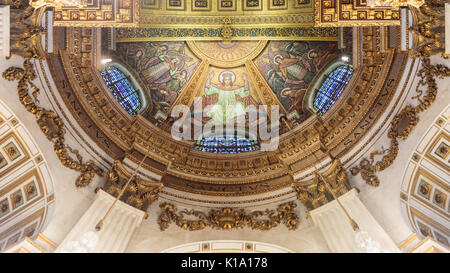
[{"xmin": 350, "ymin": 56, "xmax": 450, "ymax": 243}]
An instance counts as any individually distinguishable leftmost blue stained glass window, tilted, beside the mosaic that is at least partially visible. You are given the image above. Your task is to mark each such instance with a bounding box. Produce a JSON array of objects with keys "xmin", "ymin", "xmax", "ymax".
[{"xmin": 100, "ymin": 67, "xmax": 141, "ymax": 117}]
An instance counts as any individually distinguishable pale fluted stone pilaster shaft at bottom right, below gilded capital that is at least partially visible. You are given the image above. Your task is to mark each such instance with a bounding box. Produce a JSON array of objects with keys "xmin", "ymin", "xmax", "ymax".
[{"xmin": 310, "ymin": 189, "xmax": 399, "ymax": 253}]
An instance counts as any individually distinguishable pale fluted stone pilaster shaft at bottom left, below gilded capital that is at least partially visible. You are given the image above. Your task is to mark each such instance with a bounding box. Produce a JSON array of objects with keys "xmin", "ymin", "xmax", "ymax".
[{"xmin": 56, "ymin": 190, "xmax": 145, "ymax": 253}]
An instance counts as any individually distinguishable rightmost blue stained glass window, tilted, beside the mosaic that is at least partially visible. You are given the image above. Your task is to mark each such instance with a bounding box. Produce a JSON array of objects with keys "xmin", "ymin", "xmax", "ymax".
[{"xmin": 314, "ymin": 65, "xmax": 353, "ymax": 115}]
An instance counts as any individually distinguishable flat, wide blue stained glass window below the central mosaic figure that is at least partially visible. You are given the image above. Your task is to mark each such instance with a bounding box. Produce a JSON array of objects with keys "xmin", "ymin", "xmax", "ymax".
[{"xmin": 195, "ymin": 135, "xmax": 260, "ymax": 154}]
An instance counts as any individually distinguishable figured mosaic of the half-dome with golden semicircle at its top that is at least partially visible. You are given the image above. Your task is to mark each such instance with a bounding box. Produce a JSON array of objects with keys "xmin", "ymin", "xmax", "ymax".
[{"xmin": 115, "ymin": 41, "xmax": 340, "ymax": 127}]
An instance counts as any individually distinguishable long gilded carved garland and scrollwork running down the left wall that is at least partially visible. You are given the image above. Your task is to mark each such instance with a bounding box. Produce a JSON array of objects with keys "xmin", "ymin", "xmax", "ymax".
[{"xmin": 3, "ymin": 3, "xmax": 103, "ymax": 187}]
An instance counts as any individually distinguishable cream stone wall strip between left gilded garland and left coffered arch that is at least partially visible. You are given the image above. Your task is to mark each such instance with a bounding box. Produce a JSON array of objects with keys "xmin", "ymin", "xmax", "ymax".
[{"xmin": 0, "ymin": 56, "xmax": 100, "ymax": 244}]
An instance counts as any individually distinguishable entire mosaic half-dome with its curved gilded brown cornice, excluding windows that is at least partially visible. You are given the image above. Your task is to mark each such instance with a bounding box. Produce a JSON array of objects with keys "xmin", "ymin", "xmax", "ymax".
[{"xmin": 42, "ymin": 22, "xmax": 407, "ymax": 201}]
